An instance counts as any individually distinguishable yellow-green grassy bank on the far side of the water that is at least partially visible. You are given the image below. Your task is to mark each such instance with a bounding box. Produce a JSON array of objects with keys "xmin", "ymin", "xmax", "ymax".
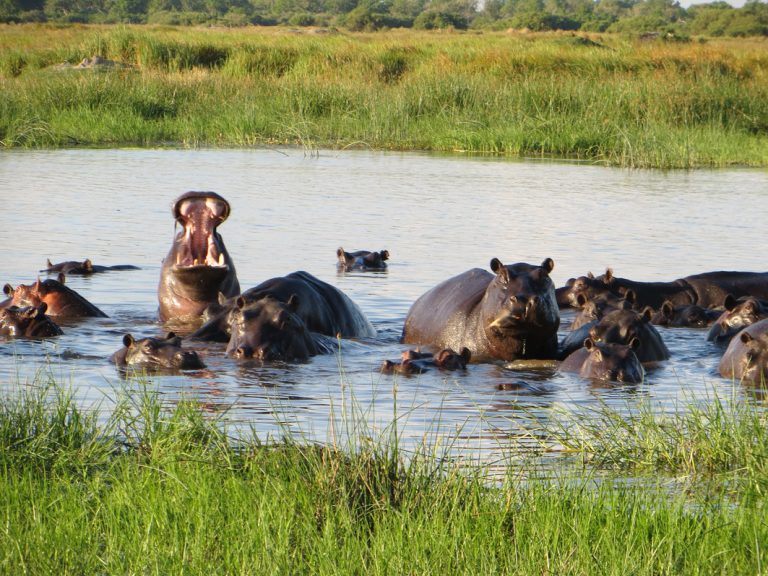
[{"xmin": 0, "ymin": 25, "xmax": 768, "ymax": 168}]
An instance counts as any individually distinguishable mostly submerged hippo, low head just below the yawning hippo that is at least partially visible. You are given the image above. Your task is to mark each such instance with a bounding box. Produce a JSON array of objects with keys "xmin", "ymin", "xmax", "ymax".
[{"xmin": 109, "ymin": 332, "xmax": 205, "ymax": 370}]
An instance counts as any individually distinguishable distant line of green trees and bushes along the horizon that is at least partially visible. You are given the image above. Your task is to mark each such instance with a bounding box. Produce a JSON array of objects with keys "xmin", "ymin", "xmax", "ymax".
[{"xmin": 0, "ymin": 0, "xmax": 768, "ymax": 39}]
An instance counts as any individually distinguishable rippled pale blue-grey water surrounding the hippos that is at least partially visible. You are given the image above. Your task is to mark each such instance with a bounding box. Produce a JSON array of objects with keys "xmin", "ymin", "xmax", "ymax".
[{"xmin": 0, "ymin": 150, "xmax": 768, "ymax": 462}]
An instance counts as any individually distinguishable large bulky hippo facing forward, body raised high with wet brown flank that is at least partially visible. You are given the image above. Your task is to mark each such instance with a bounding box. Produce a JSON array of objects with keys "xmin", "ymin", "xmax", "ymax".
[{"xmin": 402, "ymin": 258, "xmax": 560, "ymax": 362}]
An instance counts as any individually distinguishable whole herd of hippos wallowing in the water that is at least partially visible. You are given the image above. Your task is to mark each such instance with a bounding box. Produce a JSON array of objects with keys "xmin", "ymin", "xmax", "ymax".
[{"xmin": 0, "ymin": 192, "xmax": 768, "ymax": 383}]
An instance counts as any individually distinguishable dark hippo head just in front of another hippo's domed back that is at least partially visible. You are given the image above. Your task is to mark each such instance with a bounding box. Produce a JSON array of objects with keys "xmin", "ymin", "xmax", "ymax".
[{"xmin": 227, "ymin": 295, "xmax": 318, "ymax": 361}]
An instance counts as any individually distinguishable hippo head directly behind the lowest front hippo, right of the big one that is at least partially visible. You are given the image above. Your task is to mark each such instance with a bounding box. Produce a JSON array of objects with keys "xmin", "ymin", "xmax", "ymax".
[{"xmin": 589, "ymin": 307, "xmax": 669, "ymax": 362}]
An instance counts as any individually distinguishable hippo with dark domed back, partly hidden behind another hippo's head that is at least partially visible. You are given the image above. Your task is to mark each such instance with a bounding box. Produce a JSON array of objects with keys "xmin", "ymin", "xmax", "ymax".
[{"xmin": 190, "ymin": 271, "xmax": 376, "ymax": 342}]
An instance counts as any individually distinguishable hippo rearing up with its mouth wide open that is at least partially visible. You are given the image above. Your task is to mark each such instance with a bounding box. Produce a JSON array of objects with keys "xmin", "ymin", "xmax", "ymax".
[{"xmin": 157, "ymin": 192, "xmax": 240, "ymax": 321}]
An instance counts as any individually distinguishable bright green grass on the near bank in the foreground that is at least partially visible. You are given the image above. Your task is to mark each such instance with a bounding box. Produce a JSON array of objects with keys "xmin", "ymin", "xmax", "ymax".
[{"xmin": 0, "ymin": 386, "xmax": 768, "ymax": 575}]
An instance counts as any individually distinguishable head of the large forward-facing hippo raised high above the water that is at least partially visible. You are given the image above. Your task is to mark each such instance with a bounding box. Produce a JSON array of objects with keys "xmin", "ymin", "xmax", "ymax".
[{"xmin": 480, "ymin": 258, "xmax": 560, "ymax": 358}]
